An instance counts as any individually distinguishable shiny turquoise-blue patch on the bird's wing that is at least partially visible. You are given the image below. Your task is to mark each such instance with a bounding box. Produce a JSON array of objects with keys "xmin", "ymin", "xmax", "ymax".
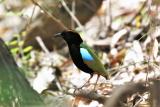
[{"xmin": 80, "ymin": 48, "xmax": 94, "ymax": 61}]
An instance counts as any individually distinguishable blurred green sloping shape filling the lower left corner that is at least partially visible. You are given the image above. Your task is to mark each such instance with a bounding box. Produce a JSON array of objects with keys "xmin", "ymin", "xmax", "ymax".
[{"xmin": 0, "ymin": 39, "xmax": 46, "ymax": 107}]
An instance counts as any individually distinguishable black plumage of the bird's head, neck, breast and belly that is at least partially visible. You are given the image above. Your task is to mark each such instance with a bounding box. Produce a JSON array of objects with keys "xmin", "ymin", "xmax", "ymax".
[{"xmin": 58, "ymin": 31, "xmax": 94, "ymax": 76}]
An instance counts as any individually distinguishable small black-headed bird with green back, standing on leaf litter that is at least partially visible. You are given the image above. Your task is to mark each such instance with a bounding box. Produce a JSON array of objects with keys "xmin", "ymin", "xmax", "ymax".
[{"xmin": 55, "ymin": 30, "xmax": 109, "ymax": 90}]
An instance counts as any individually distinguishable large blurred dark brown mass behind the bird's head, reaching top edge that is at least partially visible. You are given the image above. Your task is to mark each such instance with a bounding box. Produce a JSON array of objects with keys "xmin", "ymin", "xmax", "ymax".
[{"xmin": 24, "ymin": 0, "xmax": 103, "ymax": 51}]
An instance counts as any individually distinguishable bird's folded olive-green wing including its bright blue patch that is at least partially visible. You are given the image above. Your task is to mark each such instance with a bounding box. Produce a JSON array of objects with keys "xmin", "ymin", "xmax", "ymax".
[{"xmin": 80, "ymin": 43, "xmax": 108, "ymax": 77}]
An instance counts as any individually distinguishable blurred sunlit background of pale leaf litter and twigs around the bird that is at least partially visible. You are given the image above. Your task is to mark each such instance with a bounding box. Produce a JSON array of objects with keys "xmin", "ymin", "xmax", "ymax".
[{"xmin": 0, "ymin": 0, "xmax": 160, "ymax": 107}]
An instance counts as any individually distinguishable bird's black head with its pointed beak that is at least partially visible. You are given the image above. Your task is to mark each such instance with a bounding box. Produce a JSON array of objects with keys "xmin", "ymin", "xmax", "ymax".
[{"xmin": 55, "ymin": 30, "xmax": 83, "ymax": 45}]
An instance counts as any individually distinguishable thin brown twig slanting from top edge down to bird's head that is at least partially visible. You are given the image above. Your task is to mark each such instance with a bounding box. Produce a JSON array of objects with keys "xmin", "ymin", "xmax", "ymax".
[{"xmin": 31, "ymin": 0, "xmax": 68, "ymax": 30}]
